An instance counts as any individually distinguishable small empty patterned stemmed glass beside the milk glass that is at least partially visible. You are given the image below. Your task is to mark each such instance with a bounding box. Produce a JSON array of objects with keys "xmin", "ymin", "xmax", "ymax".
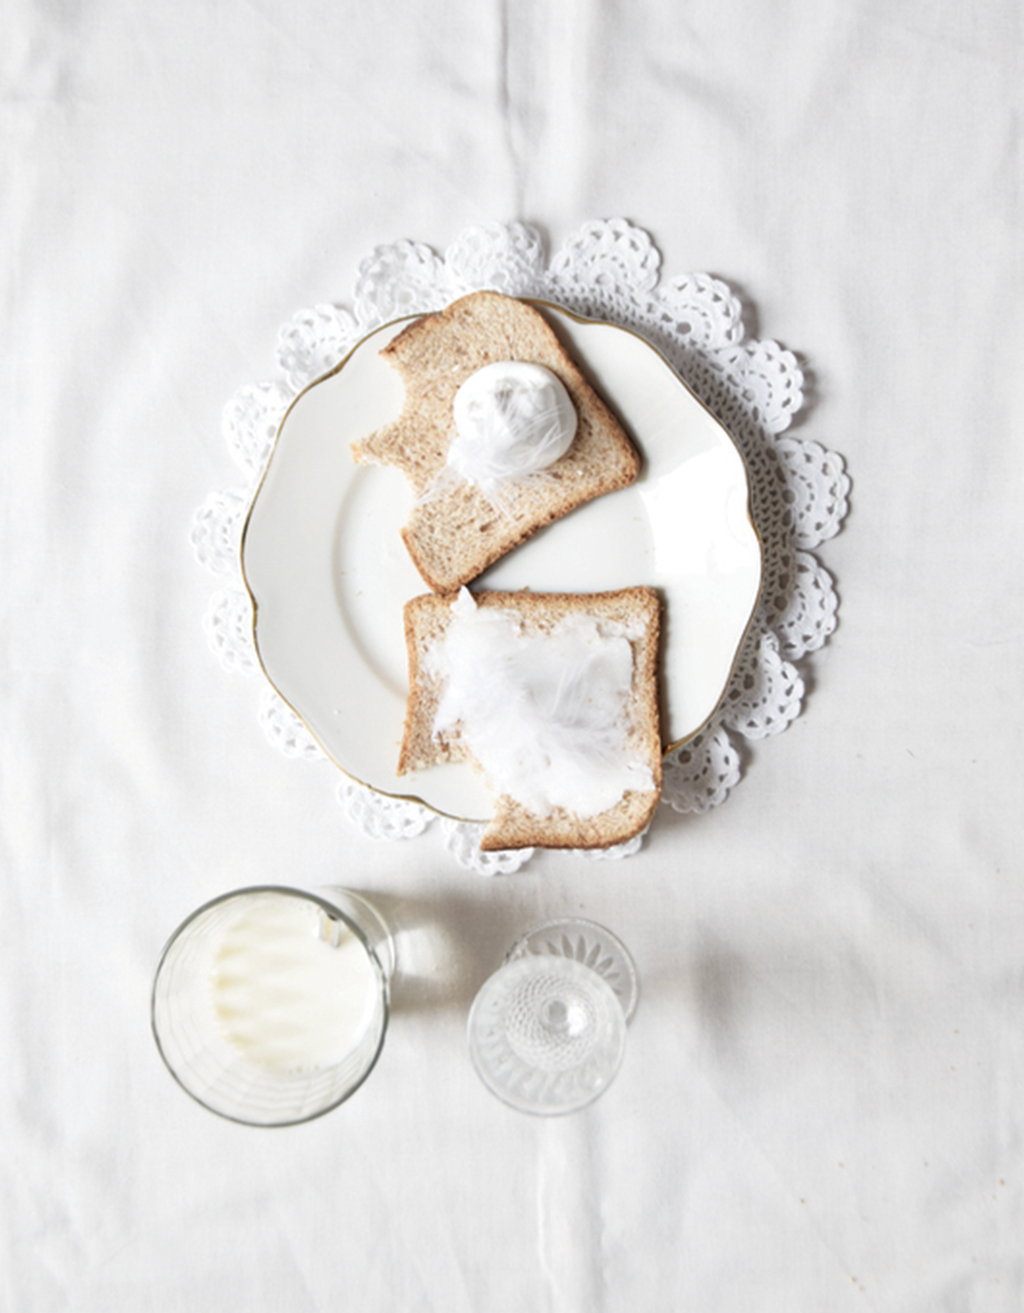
[{"xmin": 469, "ymin": 918, "xmax": 638, "ymax": 1116}]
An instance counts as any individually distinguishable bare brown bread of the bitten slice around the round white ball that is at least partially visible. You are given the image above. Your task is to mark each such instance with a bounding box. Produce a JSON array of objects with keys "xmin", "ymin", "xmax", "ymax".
[{"xmin": 352, "ymin": 291, "xmax": 641, "ymax": 592}]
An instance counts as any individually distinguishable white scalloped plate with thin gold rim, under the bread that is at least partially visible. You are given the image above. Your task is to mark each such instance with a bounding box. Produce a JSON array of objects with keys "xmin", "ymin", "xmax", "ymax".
[{"xmin": 242, "ymin": 306, "xmax": 761, "ymax": 819}]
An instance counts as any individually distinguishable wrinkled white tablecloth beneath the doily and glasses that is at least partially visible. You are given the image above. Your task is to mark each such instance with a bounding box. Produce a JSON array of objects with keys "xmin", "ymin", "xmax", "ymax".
[{"xmin": 0, "ymin": 0, "xmax": 1024, "ymax": 1313}]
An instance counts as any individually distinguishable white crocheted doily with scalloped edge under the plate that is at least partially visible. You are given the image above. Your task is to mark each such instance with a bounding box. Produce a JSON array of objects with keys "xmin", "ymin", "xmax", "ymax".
[{"xmin": 192, "ymin": 219, "xmax": 849, "ymax": 874}]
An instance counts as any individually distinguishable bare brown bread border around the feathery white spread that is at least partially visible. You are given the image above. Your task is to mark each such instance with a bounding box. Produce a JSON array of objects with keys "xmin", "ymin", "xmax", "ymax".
[{"xmin": 398, "ymin": 587, "xmax": 662, "ymax": 851}]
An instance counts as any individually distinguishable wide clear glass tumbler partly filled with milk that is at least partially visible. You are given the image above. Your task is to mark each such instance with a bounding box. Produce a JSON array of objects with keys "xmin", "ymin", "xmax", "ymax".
[{"xmin": 152, "ymin": 885, "xmax": 395, "ymax": 1127}]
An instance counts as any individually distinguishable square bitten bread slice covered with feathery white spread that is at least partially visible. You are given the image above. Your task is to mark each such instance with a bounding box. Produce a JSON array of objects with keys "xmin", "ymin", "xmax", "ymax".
[{"xmin": 398, "ymin": 587, "xmax": 662, "ymax": 851}]
